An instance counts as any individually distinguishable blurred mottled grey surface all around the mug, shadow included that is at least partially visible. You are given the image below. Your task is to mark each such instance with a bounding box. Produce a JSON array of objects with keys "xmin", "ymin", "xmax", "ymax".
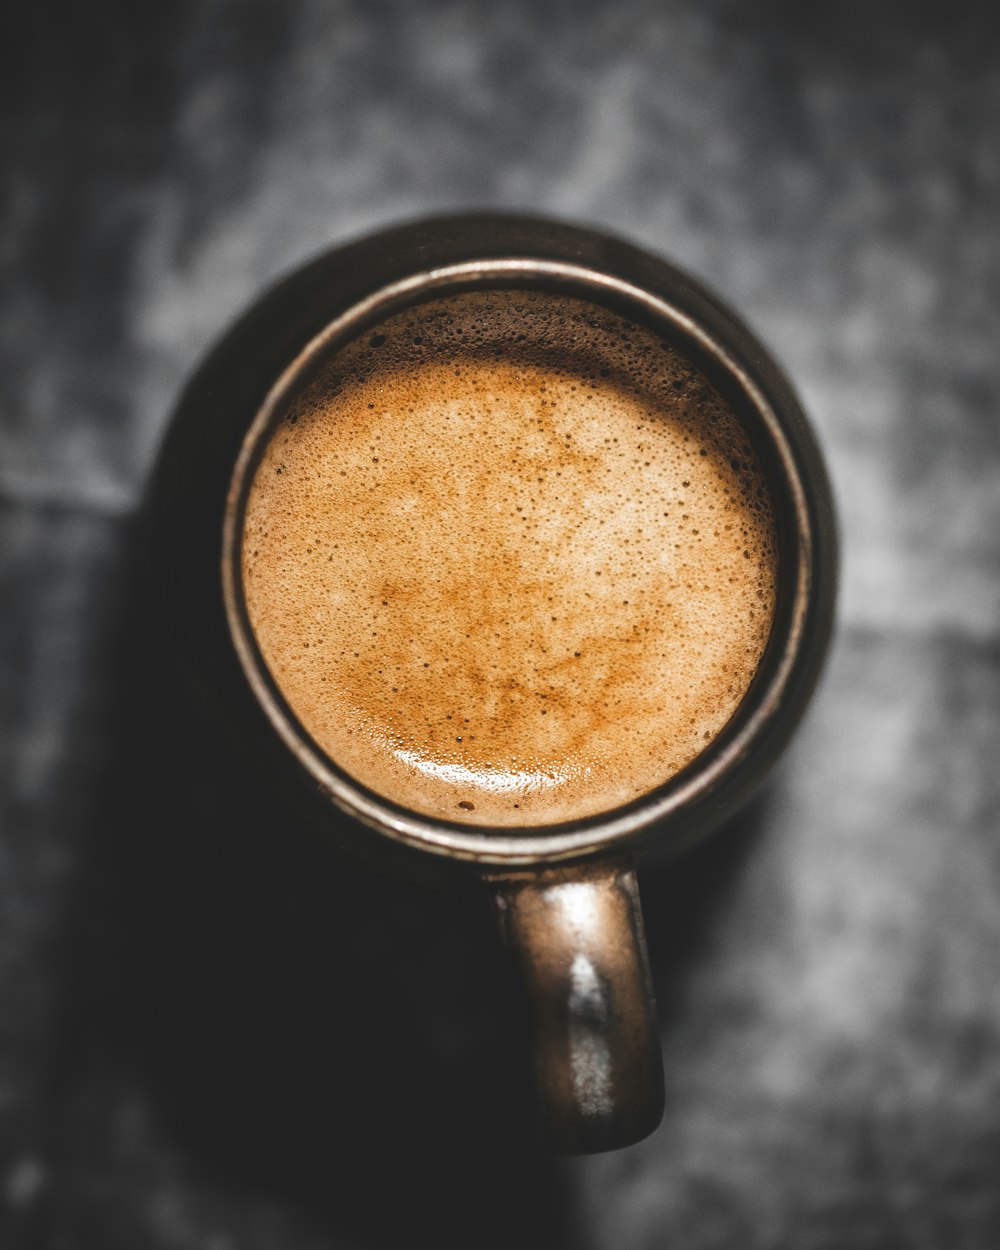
[{"xmin": 0, "ymin": 0, "xmax": 1000, "ymax": 1250}]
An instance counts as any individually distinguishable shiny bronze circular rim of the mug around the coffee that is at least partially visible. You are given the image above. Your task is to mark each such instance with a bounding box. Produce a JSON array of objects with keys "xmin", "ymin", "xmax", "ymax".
[{"xmin": 224, "ymin": 261, "xmax": 800, "ymax": 858}]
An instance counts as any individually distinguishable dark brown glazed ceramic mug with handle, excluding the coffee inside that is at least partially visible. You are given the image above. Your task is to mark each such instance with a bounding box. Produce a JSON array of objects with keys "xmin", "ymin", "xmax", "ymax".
[{"xmin": 150, "ymin": 215, "xmax": 836, "ymax": 1151}]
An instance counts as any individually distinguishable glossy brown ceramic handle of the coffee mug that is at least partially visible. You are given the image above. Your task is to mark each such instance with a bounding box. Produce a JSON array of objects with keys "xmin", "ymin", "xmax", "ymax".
[{"xmin": 488, "ymin": 860, "xmax": 664, "ymax": 1154}]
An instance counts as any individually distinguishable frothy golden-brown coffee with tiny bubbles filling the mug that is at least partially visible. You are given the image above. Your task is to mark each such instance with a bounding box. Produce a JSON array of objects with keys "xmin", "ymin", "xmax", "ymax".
[{"xmin": 243, "ymin": 290, "xmax": 778, "ymax": 826}]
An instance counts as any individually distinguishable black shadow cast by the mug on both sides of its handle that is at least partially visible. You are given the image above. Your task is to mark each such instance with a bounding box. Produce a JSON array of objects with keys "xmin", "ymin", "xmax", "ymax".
[{"xmin": 52, "ymin": 540, "xmax": 775, "ymax": 1250}]
